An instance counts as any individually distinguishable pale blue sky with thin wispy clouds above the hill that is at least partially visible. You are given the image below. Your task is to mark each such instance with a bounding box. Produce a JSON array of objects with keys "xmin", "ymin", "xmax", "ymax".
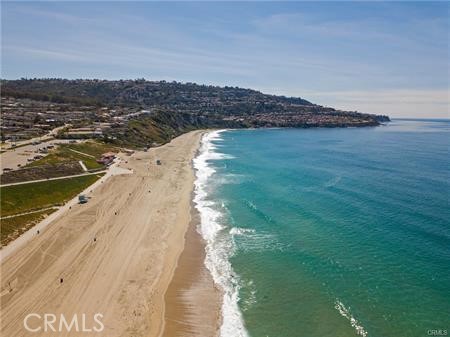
[{"xmin": 1, "ymin": 1, "xmax": 450, "ymax": 118}]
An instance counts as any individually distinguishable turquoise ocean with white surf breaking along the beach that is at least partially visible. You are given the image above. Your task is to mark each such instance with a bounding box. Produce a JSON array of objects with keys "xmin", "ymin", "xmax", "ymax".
[{"xmin": 194, "ymin": 120, "xmax": 450, "ymax": 337}]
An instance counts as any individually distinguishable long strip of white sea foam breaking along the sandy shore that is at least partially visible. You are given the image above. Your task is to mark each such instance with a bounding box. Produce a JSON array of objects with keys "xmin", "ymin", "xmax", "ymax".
[{"xmin": 194, "ymin": 131, "xmax": 248, "ymax": 337}]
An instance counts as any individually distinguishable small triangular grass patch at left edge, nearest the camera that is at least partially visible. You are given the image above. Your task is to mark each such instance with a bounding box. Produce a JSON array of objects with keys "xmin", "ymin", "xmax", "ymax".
[{"xmin": 0, "ymin": 209, "xmax": 56, "ymax": 246}]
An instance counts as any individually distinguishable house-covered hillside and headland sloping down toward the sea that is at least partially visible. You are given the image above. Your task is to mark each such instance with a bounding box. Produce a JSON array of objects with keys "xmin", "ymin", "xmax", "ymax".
[{"xmin": 2, "ymin": 79, "xmax": 389, "ymax": 146}]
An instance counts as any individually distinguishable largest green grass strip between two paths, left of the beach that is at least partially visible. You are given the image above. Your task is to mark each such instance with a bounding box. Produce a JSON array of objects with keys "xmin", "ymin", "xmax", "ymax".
[{"xmin": 0, "ymin": 174, "xmax": 102, "ymax": 216}]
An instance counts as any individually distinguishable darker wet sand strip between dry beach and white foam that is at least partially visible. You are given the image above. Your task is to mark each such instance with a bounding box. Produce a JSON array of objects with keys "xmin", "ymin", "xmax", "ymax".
[{"xmin": 161, "ymin": 191, "xmax": 223, "ymax": 337}]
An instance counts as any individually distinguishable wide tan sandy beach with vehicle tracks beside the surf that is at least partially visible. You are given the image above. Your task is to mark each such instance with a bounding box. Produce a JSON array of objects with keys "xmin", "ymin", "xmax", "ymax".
[{"xmin": 1, "ymin": 131, "xmax": 219, "ymax": 337}]
